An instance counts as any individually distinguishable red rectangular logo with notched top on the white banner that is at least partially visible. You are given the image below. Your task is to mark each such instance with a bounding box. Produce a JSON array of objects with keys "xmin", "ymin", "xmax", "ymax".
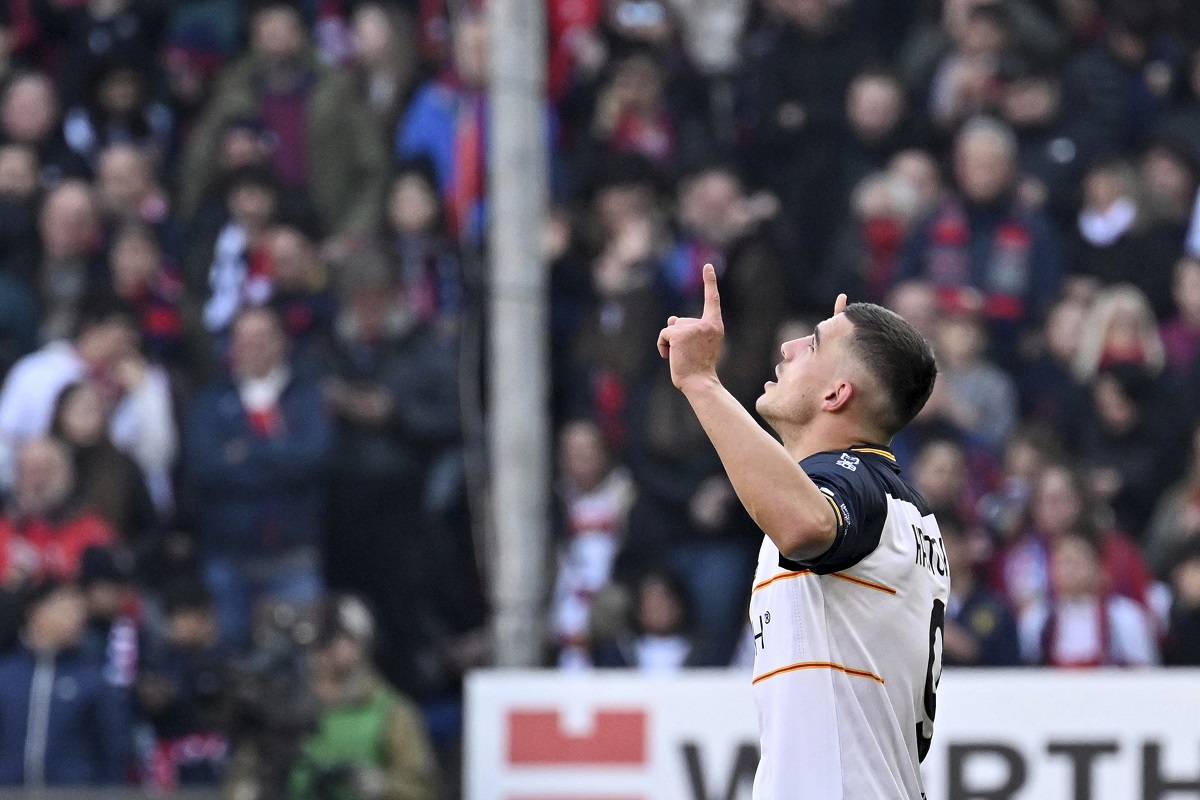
[{"xmin": 509, "ymin": 711, "xmax": 647, "ymax": 766}]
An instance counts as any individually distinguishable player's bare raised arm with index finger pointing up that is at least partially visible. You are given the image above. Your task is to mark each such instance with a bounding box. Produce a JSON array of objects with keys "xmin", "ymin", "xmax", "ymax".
[{"xmin": 659, "ymin": 264, "xmax": 845, "ymax": 560}]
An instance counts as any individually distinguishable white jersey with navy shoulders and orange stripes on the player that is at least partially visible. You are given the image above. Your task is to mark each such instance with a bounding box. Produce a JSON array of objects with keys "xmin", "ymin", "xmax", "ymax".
[{"xmin": 750, "ymin": 447, "xmax": 950, "ymax": 800}]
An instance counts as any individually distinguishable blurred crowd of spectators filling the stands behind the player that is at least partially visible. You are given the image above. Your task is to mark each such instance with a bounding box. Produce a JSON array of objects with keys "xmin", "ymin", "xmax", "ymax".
[{"xmin": 0, "ymin": 0, "xmax": 1200, "ymax": 799}]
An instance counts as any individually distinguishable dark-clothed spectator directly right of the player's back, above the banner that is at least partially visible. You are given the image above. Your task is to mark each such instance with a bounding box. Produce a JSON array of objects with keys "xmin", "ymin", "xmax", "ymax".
[{"xmin": 937, "ymin": 511, "xmax": 1020, "ymax": 667}]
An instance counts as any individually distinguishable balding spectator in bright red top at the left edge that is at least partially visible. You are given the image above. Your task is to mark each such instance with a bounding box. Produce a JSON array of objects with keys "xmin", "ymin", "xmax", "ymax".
[{"xmin": 0, "ymin": 438, "xmax": 115, "ymax": 585}]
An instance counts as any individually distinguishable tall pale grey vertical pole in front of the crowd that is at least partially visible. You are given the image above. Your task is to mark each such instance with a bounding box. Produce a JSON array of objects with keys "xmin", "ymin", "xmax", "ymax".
[{"xmin": 487, "ymin": 0, "xmax": 550, "ymax": 667}]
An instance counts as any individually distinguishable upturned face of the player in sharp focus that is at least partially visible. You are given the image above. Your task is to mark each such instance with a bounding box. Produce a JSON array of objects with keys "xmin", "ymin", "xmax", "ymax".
[{"xmin": 755, "ymin": 314, "xmax": 853, "ymax": 429}]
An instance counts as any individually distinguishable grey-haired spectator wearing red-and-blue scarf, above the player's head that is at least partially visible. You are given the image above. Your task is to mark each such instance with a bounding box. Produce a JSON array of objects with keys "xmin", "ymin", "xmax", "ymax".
[{"xmin": 900, "ymin": 118, "xmax": 1063, "ymax": 368}]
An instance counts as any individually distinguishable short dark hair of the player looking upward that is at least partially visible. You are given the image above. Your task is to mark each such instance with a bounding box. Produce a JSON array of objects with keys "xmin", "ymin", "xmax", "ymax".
[{"xmin": 845, "ymin": 302, "xmax": 937, "ymax": 437}]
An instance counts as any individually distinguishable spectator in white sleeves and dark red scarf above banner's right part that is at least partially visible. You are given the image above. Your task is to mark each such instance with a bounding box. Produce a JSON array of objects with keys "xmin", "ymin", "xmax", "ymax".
[{"xmin": 1020, "ymin": 533, "xmax": 1159, "ymax": 669}]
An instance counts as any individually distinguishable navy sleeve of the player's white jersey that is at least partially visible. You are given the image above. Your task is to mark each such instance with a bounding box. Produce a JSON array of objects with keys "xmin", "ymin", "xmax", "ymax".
[{"xmin": 797, "ymin": 453, "xmax": 887, "ymax": 575}]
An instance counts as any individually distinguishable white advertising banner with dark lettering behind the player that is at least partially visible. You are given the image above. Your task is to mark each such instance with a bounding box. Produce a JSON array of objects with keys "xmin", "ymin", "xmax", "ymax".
[{"xmin": 466, "ymin": 669, "xmax": 1200, "ymax": 800}]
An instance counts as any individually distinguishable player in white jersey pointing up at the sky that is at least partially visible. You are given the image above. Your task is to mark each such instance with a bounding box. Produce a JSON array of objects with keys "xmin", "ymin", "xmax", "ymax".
[{"xmin": 659, "ymin": 265, "xmax": 950, "ymax": 800}]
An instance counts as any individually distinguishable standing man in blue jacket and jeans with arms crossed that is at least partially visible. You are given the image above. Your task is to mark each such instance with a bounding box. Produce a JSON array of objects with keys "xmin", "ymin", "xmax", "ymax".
[{"xmin": 185, "ymin": 308, "xmax": 331, "ymax": 648}]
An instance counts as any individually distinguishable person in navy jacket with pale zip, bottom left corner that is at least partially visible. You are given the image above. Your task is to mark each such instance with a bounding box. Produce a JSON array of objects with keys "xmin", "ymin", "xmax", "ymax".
[{"xmin": 0, "ymin": 582, "xmax": 131, "ymax": 788}]
